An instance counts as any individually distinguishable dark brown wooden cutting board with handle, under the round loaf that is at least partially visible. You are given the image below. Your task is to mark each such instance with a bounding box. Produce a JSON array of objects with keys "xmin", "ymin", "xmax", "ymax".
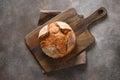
[{"xmin": 25, "ymin": 8, "xmax": 107, "ymax": 72}]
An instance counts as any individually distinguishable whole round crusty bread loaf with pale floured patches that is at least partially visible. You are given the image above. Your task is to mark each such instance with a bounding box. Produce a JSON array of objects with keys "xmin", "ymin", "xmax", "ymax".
[{"xmin": 38, "ymin": 21, "xmax": 76, "ymax": 59}]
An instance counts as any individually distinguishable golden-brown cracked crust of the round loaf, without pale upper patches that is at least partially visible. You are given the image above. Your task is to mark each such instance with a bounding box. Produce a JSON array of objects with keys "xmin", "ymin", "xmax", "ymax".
[{"xmin": 39, "ymin": 22, "xmax": 75, "ymax": 58}]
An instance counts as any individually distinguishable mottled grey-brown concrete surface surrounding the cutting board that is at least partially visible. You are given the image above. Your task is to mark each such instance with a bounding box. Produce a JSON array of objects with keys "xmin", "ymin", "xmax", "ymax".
[{"xmin": 0, "ymin": 0, "xmax": 120, "ymax": 80}]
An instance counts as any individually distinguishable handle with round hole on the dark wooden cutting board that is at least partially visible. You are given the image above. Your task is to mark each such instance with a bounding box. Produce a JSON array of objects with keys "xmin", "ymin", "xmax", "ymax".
[{"xmin": 84, "ymin": 7, "xmax": 107, "ymax": 28}]
